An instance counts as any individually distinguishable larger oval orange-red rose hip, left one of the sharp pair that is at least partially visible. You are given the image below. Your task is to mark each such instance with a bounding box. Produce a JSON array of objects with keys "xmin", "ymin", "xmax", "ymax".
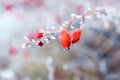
[{"xmin": 59, "ymin": 29, "xmax": 71, "ymax": 49}]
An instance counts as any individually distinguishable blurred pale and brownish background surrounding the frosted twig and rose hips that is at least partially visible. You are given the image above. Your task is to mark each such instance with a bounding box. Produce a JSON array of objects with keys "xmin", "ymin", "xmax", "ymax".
[{"xmin": 0, "ymin": 0, "xmax": 120, "ymax": 80}]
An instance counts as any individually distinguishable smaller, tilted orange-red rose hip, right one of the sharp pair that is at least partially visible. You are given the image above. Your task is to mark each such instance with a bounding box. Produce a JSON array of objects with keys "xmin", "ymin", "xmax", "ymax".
[{"xmin": 71, "ymin": 29, "xmax": 82, "ymax": 43}]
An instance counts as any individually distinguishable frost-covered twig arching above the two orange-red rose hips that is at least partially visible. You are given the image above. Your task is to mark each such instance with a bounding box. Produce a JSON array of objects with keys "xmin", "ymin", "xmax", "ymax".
[{"xmin": 22, "ymin": 7, "xmax": 120, "ymax": 48}]
